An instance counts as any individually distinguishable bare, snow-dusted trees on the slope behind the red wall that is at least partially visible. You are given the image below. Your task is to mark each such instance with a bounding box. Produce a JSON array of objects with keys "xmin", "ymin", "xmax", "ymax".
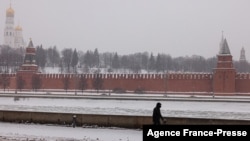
[{"xmin": 0, "ymin": 45, "xmax": 250, "ymax": 73}]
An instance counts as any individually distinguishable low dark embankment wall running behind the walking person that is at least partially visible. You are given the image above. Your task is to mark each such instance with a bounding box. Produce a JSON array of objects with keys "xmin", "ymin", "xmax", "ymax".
[{"xmin": 0, "ymin": 110, "xmax": 250, "ymax": 128}]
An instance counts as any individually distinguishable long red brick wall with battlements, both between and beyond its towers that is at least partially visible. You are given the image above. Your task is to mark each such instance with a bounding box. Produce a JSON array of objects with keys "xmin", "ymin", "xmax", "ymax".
[{"xmin": 0, "ymin": 73, "xmax": 250, "ymax": 93}]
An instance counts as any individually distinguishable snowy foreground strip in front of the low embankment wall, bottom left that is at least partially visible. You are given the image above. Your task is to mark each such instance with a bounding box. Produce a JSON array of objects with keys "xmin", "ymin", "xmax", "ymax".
[{"xmin": 0, "ymin": 122, "xmax": 142, "ymax": 141}]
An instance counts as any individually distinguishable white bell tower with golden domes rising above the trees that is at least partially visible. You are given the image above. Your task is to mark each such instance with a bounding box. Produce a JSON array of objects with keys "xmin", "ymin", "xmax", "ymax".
[{"xmin": 4, "ymin": 5, "xmax": 25, "ymax": 48}]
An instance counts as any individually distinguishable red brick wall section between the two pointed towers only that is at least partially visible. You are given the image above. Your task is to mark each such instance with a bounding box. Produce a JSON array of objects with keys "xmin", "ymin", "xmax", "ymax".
[{"xmin": 40, "ymin": 74, "xmax": 212, "ymax": 92}]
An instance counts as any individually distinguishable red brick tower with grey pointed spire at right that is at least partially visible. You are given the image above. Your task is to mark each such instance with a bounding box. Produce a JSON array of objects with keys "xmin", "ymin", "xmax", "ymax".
[{"xmin": 213, "ymin": 35, "xmax": 236, "ymax": 94}]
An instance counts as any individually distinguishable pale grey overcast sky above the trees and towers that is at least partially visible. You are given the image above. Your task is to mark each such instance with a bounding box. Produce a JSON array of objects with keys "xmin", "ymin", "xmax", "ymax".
[{"xmin": 0, "ymin": 0, "xmax": 250, "ymax": 60}]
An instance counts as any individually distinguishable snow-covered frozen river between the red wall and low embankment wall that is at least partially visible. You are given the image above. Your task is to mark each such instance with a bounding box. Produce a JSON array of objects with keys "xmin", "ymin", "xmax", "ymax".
[{"xmin": 0, "ymin": 94, "xmax": 250, "ymax": 120}]
